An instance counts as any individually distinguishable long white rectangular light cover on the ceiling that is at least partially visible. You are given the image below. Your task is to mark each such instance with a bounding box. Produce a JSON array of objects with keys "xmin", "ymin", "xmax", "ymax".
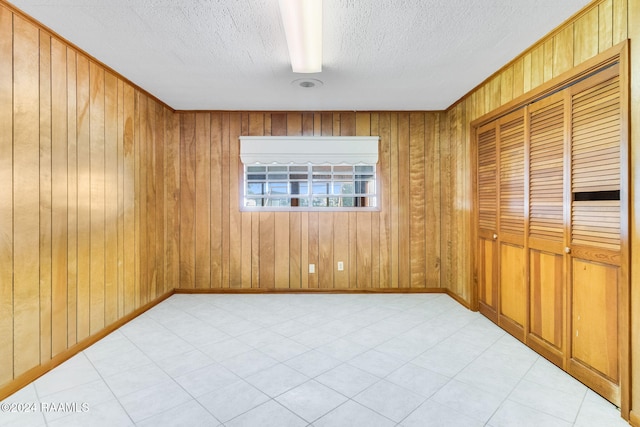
[{"xmin": 279, "ymin": 0, "xmax": 322, "ymax": 73}]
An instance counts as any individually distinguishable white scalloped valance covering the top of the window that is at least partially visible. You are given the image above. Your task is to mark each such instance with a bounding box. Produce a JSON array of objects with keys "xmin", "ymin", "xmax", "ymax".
[{"xmin": 240, "ymin": 136, "xmax": 380, "ymax": 165}]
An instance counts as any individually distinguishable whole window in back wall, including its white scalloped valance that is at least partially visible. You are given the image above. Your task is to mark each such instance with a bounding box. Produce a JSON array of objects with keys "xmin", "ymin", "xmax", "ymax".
[{"xmin": 241, "ymin": 137, "xmax": 378, "ymax": 210}]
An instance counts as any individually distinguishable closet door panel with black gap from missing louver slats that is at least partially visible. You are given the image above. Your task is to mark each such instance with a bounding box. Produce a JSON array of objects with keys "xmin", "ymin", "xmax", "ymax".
[{"xmin": 569, "ymin": 67, "xmax": 622, "ymax": 403}]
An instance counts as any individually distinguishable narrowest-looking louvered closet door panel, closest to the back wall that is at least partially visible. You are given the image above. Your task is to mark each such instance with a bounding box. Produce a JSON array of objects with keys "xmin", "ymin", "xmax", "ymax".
[{"xmin": 476, "ymin": 122, "xmax": 498, "ymax": 322}]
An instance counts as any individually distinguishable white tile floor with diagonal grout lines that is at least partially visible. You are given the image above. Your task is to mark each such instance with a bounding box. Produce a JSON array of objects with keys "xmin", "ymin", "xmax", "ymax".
[{"xmin": 0, "ymin": 294, "xmax": 627, "ymax": 427}]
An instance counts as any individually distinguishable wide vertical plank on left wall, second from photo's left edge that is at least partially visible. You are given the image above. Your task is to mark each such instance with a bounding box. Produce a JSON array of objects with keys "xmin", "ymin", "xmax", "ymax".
[{"xmin": 13, "ymin": 17, "xmax": 40, "ymax": 375}]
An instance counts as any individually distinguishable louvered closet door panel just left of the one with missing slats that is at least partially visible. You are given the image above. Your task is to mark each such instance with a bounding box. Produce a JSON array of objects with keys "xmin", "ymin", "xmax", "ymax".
[{"xmin": 528, "ymin": 92, "xmax": 568, "ymax": 366}]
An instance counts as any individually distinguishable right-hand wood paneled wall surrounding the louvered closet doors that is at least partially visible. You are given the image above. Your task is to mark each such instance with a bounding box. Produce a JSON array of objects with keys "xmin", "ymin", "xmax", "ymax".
[{"xmin": 440, "ymin": 0, "xmax": 640, "ymax": 426}]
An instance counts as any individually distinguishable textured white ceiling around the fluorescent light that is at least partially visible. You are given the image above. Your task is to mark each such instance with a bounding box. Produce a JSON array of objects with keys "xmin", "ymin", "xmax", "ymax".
[{"xmin": 12, "ymin": 0, "xmax": 589, "ymax": 110}]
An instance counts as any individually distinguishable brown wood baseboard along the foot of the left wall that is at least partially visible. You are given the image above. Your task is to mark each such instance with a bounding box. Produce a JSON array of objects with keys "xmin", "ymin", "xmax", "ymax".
[{"xmin": 0, "ymin": 290, "xmax": 174, "ymax": 401}]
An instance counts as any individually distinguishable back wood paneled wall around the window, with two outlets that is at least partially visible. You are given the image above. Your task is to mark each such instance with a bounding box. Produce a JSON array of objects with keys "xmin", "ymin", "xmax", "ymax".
[{"xmin": 179, "ymin": 112, "xmax": 443, "ymax": 289}]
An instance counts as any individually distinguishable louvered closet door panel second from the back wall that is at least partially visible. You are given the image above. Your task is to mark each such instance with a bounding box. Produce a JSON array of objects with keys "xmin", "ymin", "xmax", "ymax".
[{"xmin": 497, "ymin": 110, "xmax": 526, "ymax": 340}]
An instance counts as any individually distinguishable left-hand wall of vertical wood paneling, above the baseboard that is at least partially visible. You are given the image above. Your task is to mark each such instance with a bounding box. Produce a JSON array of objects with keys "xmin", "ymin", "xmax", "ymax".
[{"xmin": 0, "ymin": 4, "xmax": 179, "ymax": 397}]
